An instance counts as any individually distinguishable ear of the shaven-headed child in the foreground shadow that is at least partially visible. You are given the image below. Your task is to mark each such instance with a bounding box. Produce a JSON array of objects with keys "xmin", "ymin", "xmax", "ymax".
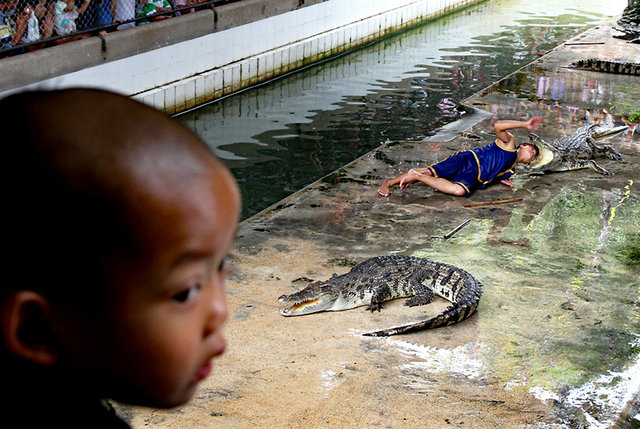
[{"xmin": 2, "ymin": 290, "xmax": 57, "ymax": 365}]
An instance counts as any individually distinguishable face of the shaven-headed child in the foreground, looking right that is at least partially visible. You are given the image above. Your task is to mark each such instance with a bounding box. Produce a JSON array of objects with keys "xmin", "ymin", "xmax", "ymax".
[{"xmin": 54, "ymin": 155, "xmax": 240, "ymax": 407}]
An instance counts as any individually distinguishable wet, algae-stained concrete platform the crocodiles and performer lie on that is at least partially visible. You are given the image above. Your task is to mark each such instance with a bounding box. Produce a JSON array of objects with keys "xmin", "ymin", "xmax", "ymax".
[{"xmin": 118, "ymin": 18, "xmax": 640, "ymax": 428}]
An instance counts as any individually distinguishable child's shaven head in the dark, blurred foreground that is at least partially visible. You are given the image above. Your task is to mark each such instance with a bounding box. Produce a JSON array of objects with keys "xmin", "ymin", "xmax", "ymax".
[{"xmin": 0, "ymin": 89, "xmax": 240, "ymax": 407}]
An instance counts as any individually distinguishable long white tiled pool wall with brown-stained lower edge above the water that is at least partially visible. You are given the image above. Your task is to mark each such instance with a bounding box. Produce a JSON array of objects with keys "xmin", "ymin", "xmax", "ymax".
[{"xmin": 8, "ymin": 0, "xmax": 481, "ymax": 113}]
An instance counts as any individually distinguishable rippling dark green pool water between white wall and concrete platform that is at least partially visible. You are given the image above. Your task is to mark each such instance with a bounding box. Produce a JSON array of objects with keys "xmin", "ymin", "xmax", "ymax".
[{"xmin": 178, "ymin": 0, "xmax": 626, "ymax": 218}]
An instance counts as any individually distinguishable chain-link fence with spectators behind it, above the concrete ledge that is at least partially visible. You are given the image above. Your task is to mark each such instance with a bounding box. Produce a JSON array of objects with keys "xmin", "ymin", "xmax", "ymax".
[{"xmin": 0, "ymin": 0, "xmax": 240, "ymax": 58}]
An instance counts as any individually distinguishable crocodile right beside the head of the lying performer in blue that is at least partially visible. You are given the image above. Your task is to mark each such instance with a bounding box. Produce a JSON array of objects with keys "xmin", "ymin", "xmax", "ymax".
[{"xmin": 529, "ymin": 124, "xmax": 629, "ymax": 176}]
